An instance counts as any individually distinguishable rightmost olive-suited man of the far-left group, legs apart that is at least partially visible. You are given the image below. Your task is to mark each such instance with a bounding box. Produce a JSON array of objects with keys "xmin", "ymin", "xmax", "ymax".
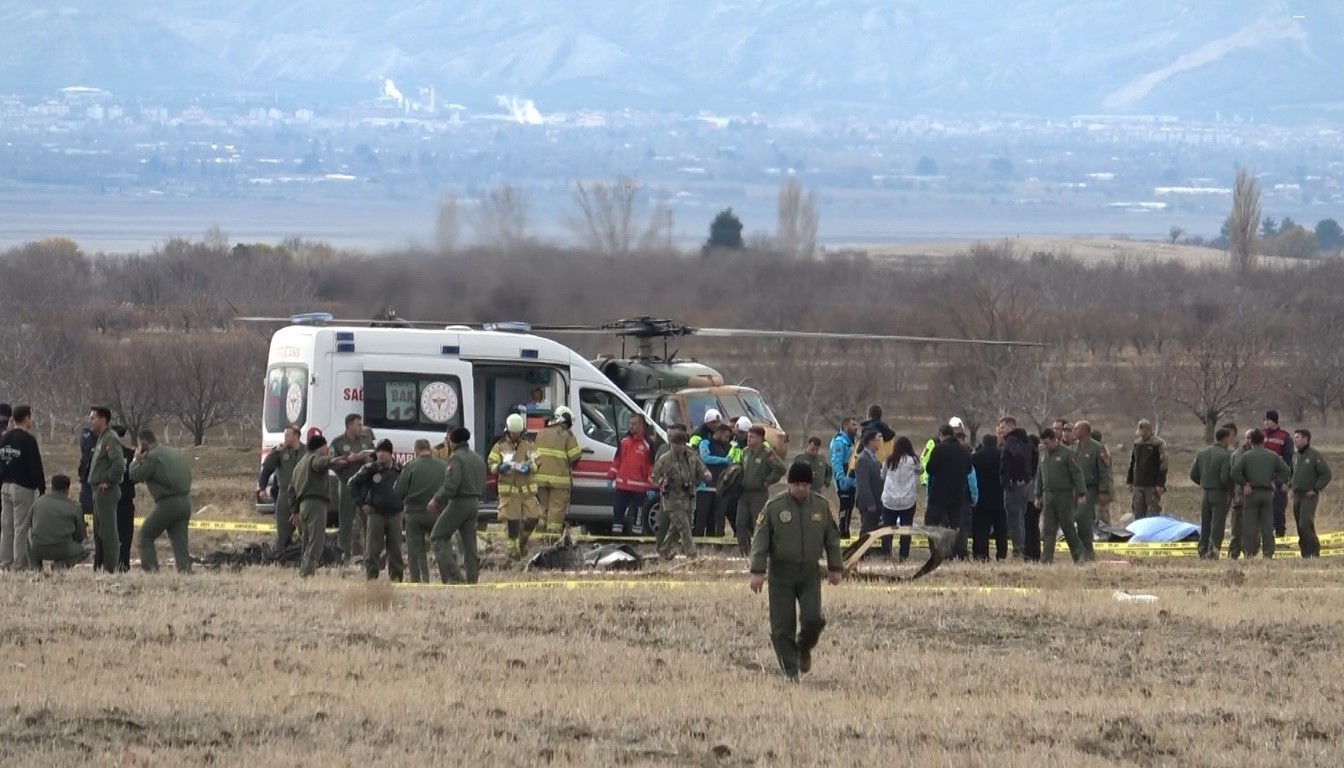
[{"xmin": 130, "ymin": 429, "xmax": 191, "ymax": 573}]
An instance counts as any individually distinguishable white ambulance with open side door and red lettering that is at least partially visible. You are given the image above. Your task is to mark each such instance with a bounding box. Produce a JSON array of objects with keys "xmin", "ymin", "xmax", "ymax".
[{"xmin": 258, "ymin": 313, "xmax": 667, "ymax": 530}]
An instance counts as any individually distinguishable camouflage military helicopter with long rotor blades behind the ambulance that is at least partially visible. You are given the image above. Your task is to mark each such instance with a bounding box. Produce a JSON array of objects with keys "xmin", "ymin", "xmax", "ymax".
[{"xmin": 531, "ymin": 316, "xmax": 1039, "ymax": 457}]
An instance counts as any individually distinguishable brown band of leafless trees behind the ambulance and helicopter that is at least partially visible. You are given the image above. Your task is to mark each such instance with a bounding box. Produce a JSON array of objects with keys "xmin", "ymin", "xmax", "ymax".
[{"xmin": 0, "ymin": 170, "xmax": 1344, "ymax": 444}]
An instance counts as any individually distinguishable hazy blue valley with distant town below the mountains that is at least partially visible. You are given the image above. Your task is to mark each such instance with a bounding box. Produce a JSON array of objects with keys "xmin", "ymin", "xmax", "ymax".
[{"xmin": 0, "ymin": 81, "xmax": 1344, "ymax": 252}]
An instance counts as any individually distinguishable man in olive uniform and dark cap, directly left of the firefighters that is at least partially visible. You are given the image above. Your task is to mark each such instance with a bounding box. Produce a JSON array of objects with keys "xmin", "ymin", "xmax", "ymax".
[{"xmin": 429, "ymin": 426, "xmax": 487, "ymax": 584}]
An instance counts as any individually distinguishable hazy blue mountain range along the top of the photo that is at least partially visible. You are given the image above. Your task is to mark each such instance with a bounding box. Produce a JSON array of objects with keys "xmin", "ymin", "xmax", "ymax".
[{"xmin": 0, "ymin": 0, "xmax": 1344, "ymax": 118}]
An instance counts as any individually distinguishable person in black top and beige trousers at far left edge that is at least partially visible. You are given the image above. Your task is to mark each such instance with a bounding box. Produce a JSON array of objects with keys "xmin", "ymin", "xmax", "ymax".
[{"xmin": 0, "ymin": 405, "xmax": 47, "ymax": 570}]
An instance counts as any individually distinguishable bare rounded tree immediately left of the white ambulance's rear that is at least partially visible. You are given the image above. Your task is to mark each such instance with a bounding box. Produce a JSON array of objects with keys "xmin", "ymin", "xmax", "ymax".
[{"xmin": 160, "ymin": 334, "xmax": 265, "ymax": 445}]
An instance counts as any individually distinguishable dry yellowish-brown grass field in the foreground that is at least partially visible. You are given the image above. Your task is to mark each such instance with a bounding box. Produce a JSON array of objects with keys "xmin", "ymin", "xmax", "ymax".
[{"xmin": 0, "ymin": 561, "xmax": 1344, "ymax": 767}]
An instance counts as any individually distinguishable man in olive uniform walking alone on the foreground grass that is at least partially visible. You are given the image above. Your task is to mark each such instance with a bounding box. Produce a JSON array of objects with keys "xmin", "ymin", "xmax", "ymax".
[{"xmin": 750, "ymin": 464, "xmax": 844, "ymax": 682}]
